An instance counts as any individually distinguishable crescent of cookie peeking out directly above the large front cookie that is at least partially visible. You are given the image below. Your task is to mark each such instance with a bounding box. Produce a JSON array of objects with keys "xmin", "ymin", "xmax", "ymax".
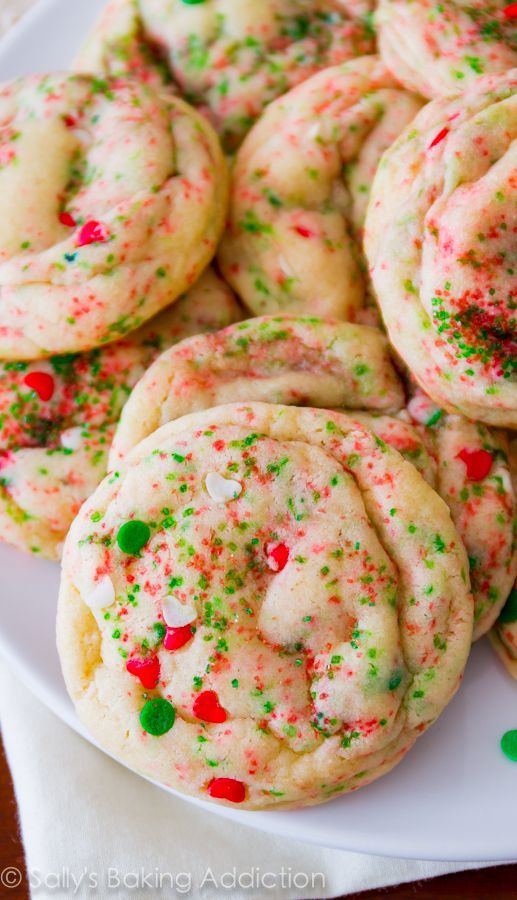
[{"xmin": 110, "ymin": 316, "xmax": 404, "ymax": 460}]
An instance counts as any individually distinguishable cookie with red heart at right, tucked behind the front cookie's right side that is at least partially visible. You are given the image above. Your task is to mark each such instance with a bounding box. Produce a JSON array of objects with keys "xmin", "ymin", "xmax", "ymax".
[{"xmin": 326, "ymin": 404, "xmax": 517, "ymax": 640}]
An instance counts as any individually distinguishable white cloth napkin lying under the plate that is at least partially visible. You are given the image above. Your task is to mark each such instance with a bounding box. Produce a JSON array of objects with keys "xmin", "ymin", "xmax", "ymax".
[{"xmin": 0, "ymin": 664, "xmax": 494, "ymax": 900}]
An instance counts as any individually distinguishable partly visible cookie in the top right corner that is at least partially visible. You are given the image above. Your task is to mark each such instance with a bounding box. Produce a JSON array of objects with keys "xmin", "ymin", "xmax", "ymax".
[{"xmin": 375, "ymin": 0, "xmax": 517, "ymax": 99}]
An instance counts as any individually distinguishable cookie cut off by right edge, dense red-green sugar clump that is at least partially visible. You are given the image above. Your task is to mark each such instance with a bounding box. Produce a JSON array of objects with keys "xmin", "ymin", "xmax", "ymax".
[{"xmin": 365, "ymin": 69, "xmax": 517, "ymax": 427}]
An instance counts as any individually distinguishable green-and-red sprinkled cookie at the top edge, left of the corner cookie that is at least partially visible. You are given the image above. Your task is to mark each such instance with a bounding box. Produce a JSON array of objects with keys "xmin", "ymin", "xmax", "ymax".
[{"xmin": 75, "ymin": 0, "xmax": 374, "ymax": 150}]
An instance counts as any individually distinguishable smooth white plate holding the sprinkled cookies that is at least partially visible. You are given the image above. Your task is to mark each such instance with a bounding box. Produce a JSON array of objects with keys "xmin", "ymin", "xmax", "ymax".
[{"xmin": 0, "ymin": 0, "xmax": 517, "ymax": 861}]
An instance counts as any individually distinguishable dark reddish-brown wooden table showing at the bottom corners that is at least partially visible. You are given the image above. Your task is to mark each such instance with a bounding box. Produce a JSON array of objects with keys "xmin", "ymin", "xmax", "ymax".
[{"xmin": 0, "ymin": 743, "xmax": 517, "ymax": 900}]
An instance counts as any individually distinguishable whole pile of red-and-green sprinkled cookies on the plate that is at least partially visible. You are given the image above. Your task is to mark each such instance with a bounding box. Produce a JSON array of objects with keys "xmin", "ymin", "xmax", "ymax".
[{"xmin": 0, "ymin": 0, "xmax": 517, "ymax": 809}]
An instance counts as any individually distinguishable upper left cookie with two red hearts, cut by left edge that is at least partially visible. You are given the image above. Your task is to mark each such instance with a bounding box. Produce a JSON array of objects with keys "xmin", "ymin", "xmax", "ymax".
[{"xmin": 0, "ymin": 74, "xmax": 227, "ymax": 360}]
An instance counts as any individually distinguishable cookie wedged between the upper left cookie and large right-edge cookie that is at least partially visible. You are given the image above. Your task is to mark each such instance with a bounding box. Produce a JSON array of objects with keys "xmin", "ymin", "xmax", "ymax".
[{"xmin": 219, "ymin": 56, "xmax": 421, "ymax": 320}]
